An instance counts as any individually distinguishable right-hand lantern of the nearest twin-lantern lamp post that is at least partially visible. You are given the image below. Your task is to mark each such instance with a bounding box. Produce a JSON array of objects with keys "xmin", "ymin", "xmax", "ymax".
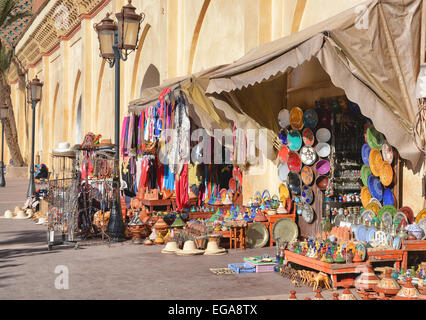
[{"xmin": 115, "ymin": 0, "xmax": 145, "ymax": 53}]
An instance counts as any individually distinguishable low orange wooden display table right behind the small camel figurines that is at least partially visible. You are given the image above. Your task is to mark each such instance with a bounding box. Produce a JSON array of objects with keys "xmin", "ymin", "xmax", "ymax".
[{"xmin": 284, "ymin": 250, "xmax": 366, "ymax": 289}]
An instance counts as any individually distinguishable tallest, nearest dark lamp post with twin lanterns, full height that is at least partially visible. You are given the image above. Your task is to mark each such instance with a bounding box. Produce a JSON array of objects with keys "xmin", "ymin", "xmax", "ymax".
[{"xmin": 93, "ymin": 0, "xmax": 145, "ymax": 242}]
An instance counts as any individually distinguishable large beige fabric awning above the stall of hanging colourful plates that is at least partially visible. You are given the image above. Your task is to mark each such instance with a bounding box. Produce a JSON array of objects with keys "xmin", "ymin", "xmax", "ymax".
[{"xmin": 206, "ymin": 0, "xmax": 423, "ymax": 167}]
